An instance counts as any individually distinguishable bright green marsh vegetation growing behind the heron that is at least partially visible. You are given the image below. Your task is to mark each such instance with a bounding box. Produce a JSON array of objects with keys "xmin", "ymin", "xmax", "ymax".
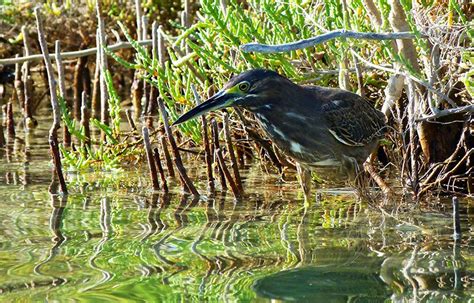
[{"xmin": 3, "ymin": 0, "xmax": 474, "ymax": 195}]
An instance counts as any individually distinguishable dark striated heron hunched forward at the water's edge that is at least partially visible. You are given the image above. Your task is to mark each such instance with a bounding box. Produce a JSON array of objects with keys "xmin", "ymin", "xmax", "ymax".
[{"xmin": 174, "ymin": 69, "xmax": 386, "ymax": 198}]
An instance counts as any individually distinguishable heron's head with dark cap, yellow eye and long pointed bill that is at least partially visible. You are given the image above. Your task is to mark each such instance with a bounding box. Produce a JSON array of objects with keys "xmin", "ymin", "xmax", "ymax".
[{"xmin": 173, "ymin": 69, "xmax": 293, "ymax": 125}]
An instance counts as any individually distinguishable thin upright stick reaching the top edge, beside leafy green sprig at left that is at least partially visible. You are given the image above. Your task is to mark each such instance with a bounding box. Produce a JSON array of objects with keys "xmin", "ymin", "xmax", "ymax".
[{"xmin": 96, "ymin": 1, "xmax": 109, "ymax": 141}]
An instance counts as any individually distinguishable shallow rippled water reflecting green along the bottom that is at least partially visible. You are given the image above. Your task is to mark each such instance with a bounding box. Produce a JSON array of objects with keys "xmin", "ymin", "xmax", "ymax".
[{"xmin": 0, "ymin": 115, "xmax": 474, "ymax": 302}]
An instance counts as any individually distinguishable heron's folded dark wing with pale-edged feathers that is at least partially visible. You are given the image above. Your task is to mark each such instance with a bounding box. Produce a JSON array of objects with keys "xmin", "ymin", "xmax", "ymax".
[{"xmin": 321, "ymin": 91, "xmax": 386, "ymax": 146}]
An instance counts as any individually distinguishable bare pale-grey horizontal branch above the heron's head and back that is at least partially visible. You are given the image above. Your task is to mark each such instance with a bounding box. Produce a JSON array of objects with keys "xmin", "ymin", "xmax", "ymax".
[{"xmin": 240, "ymin": 29, "xmax": 416, "ymax": 54}]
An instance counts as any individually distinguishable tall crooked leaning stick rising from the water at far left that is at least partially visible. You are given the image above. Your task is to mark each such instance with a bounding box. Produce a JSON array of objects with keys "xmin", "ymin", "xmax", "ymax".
[{"xmin": 35, "ymin": 7, "xmax": 67, "ymax": 194}]
